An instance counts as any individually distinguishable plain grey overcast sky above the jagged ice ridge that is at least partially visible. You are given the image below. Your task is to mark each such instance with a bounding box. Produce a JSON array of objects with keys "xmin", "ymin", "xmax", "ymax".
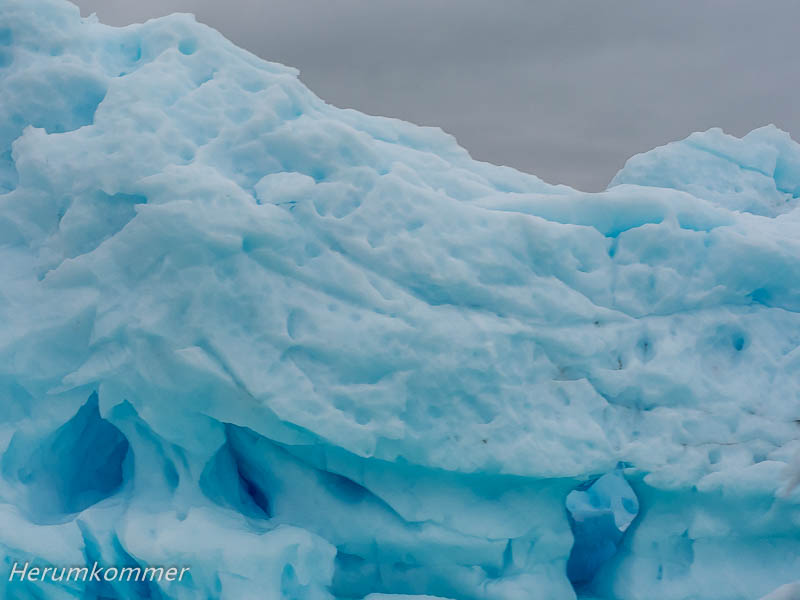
[{"xmin": 76, "ymin": 0, "xmax": 800, "ymax": 190}]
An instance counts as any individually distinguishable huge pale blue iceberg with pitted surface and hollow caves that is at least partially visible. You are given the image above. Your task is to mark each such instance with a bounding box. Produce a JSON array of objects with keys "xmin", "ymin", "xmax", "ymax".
[{"xmin": 0, "ymin": 0, "xmax": 800, "ymax": 600}]
